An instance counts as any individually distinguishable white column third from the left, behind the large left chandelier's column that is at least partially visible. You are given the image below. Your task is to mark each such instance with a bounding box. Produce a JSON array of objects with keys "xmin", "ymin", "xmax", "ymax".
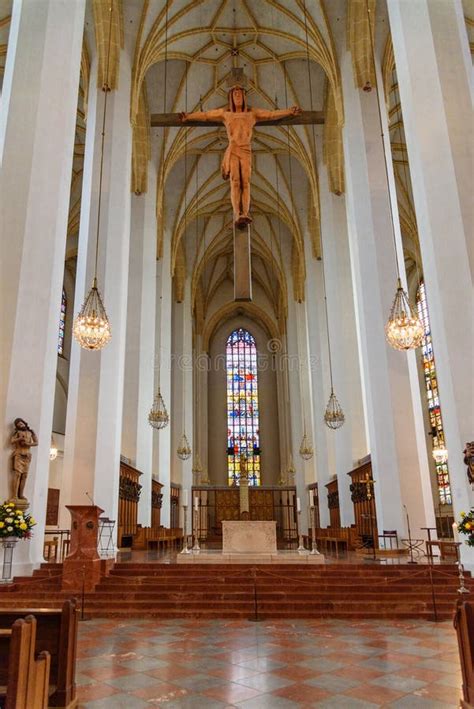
[{"xmin": 122, "ymin": 169, "xmax": 156, "ymax": 527}]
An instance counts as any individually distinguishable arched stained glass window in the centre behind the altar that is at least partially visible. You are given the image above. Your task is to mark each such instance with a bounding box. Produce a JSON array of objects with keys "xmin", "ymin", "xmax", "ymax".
[{"xmin": 226, "ymin": 328, "xmax": 260, "ymax": 485}]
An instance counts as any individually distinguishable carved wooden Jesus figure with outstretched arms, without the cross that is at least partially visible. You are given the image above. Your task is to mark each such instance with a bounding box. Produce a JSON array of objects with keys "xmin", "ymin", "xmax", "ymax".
[{"xmin": 181, "ymin": 85, "xmax": 301, "ymax": 229}]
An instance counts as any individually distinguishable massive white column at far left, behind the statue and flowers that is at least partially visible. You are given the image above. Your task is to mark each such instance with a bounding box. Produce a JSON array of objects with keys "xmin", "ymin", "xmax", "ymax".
[{"xmin": 0, "ymin": 0, "xmax": 85, "ymax": 572}]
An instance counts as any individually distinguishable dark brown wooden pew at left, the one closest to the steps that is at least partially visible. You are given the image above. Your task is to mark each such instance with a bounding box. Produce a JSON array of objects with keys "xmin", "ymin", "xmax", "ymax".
[{"xmin": 0, "ymin": 599, "xmax": 79, "ymax": 709}]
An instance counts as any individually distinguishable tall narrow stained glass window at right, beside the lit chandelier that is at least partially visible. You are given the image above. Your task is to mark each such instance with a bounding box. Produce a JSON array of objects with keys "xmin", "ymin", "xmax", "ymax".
[{"xmin": 416, "ymin": 281, "xmax": 452, "ymax": 505}]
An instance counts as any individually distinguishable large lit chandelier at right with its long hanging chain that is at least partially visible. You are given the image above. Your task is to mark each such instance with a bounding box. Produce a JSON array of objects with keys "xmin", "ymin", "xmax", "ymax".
[{"xmin": 366, "ymin": 0, "xmax": 423, "ymax": 350}]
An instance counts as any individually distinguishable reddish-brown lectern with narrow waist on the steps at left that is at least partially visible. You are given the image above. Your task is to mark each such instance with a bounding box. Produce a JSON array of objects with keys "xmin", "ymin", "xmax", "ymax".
[{"xmin": 62, "ymin": 505, "xmax": 104, "ymax": 591}]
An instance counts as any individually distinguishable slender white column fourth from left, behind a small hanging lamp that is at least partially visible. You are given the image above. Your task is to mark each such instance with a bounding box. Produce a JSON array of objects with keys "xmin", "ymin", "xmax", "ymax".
[{"xmin": 154, "ymin": 231, "xmax": 174, "ymax": 527}]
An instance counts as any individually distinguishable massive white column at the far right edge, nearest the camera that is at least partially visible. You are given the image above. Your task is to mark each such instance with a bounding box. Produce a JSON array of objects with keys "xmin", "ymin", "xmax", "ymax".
[{"xmin": 388, "ymin": 0, "xmax": 474, "ymax": 567}]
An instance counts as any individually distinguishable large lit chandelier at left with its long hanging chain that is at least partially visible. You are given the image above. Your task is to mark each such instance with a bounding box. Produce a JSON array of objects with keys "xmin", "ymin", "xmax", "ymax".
[{"xmin": 73, "ymin": 4, "xmax": 113, "ymax": 350}]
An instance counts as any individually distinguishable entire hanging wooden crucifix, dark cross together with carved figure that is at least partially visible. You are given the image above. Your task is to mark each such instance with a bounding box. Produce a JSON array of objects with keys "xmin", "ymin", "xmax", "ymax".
[{"xmin": 151, "ymin": 68, "xmax": 324, "ymax": 301}]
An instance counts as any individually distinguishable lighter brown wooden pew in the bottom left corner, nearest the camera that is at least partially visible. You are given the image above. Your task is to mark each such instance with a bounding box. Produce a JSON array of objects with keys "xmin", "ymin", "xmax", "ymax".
[{"xmin": 0, "ymin": 615, "xmax": 51, "ymax": 709}]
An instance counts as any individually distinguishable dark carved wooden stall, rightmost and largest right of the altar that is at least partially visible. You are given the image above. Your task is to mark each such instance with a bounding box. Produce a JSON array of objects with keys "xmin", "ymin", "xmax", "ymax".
[{"xmin": 348, "ymin": 460, "xmax": 378, "ymax": 548}]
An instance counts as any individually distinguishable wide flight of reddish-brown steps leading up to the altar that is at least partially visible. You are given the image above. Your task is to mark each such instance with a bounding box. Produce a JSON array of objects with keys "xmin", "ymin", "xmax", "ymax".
[{"xmin": 0, "ymin": 563, "xmax": 474, "ymax": 619}]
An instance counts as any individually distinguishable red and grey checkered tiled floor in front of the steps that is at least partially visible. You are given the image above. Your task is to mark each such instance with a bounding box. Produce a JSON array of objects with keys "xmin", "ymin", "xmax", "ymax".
[{"xmin": 77, "ymin": 619, "xmax": 461, "ymax": 709}]
